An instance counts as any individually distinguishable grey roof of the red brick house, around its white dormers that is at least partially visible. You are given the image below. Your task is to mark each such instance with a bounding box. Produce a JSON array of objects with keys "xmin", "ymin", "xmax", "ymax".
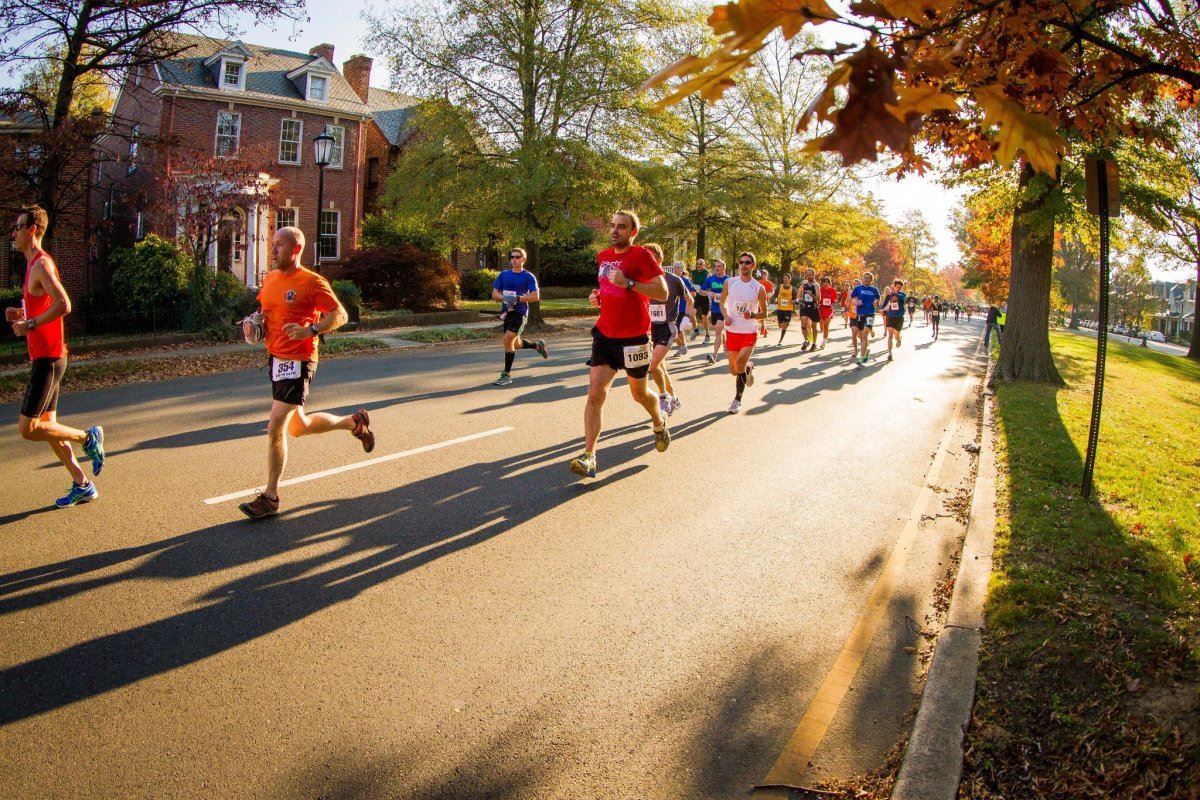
[{"xmin": 158, "ymin": 34, "xmax": 371, "ymax": 116}]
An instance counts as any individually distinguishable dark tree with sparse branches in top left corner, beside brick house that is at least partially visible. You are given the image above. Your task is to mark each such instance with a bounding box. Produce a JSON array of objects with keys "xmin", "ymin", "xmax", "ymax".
[{"xmin": 0, "ymin": 0, "xmax": 304, "ymax": 241}]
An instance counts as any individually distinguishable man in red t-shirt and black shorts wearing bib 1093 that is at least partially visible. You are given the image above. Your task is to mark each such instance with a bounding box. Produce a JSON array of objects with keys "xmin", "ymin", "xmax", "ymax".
[{"xmin": 571, "ymin": 210, "xmax": 671, "ymax": 477}]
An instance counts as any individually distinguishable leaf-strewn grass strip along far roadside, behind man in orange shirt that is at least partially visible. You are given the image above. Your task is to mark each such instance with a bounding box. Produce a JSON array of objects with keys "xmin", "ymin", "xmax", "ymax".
[{"xmin": 0, "ymin": 336, "xmax": 388, "ymax": 403}]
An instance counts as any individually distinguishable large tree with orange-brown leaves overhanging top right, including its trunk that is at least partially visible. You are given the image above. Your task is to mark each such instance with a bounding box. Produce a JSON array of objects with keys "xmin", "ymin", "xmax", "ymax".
[{"xmin": 652, "ymin": 0, "xmax": 1200, "ymax": 383}]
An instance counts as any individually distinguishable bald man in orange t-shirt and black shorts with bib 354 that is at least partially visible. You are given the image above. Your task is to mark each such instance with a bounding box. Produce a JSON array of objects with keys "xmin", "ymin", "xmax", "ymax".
[{"xmin": 239, "ymin": 228, "xmax": 374, "ymax": 519}]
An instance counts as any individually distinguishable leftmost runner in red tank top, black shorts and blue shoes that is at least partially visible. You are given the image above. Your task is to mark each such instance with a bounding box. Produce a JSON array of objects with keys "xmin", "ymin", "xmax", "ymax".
[{"xmin": 5, "ymin": 205, "xmax": 104, "ymax": 509}]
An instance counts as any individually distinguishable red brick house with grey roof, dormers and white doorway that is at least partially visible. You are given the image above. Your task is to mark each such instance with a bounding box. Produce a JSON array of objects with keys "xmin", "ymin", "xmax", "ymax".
[{"xmin": 100, "ymin": 34, "xmax": 374, "ymax": 285}]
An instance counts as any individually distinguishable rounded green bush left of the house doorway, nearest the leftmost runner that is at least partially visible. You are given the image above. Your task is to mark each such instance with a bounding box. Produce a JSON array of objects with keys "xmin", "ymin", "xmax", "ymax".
[{"xmin": 108, "ymin": 234, "xmax": 191, "ymax": 314}]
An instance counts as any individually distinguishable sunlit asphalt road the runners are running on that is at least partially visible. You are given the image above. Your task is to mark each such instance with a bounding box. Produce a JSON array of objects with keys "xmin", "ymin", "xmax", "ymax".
[{"xmin": 0, "ymin": 320, "xmax": 982, "ymax": 800}]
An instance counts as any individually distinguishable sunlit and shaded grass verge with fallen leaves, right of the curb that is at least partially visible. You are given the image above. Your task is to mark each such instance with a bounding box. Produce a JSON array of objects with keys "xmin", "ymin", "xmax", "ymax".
[{"xmin": 960, "ymin": 333, "xmax": 1200, "ymax": 799}]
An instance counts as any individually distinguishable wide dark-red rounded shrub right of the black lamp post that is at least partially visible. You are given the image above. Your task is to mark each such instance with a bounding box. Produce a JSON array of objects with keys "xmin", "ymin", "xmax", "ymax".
[{"xmin": 342, "ymin": 245, "xmax": 458, "ymax": 312}]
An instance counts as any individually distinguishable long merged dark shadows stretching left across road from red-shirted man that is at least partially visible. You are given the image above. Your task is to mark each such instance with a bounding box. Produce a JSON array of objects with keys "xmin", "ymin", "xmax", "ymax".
[{"xmin": 0, "ymin": 414, "xmax": 722, "ymax": 724}]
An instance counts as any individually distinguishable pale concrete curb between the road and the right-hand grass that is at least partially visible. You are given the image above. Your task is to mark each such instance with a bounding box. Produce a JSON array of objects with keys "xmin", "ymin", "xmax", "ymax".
[{"xmin": 892, "ymin": 381, "xmax": 996, "ymax": 800}]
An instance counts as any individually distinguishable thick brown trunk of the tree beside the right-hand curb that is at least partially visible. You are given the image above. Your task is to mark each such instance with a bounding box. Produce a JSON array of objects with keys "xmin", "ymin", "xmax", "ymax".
[{"xmin": 996, "ymin": 164, "xmax": 1063, "ymax": 385}]
